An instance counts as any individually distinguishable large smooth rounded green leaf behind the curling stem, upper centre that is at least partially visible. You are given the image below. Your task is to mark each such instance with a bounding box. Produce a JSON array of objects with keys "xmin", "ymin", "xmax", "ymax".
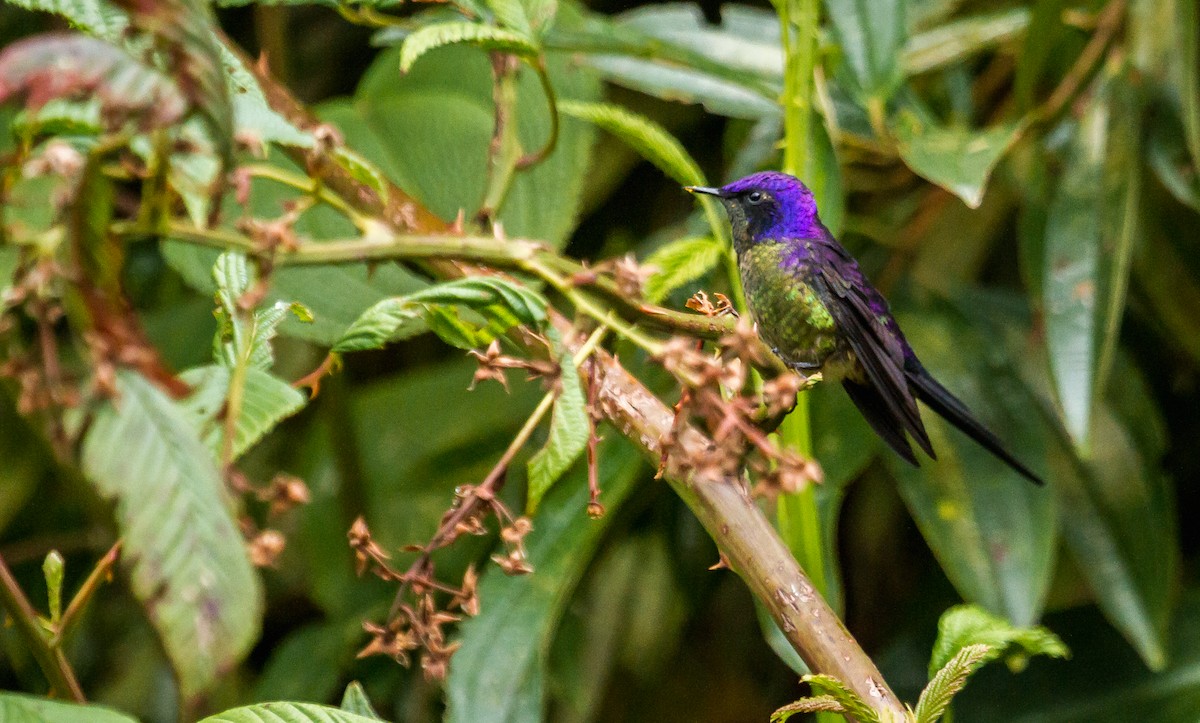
[{"xmin": 348, "ymin": 46, "xmax": 600, "ymax": 245}]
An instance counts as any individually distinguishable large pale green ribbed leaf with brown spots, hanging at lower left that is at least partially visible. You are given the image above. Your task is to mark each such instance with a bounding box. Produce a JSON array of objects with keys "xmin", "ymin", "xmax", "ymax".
[{"xmin": 82, "ymin": 371, "xmax": 263, "ymax": 698}]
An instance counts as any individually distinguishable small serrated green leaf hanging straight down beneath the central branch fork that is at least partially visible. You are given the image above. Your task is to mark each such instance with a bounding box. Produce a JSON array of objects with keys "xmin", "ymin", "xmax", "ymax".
[{"xmin": 526, "ymin": 331, "xmax": 592, "ymax": 514}]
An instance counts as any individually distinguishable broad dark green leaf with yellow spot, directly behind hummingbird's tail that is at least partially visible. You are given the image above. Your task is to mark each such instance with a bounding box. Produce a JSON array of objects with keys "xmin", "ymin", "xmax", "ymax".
[{"xmin": 886, "ymin": 301, "xmax": 1057, "ymax": 625}]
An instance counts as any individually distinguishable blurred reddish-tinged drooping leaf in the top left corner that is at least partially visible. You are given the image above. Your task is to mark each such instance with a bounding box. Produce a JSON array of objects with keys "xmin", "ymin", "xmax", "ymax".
[{"xmin": 0, "ymin": 34, "xmax": 187, "ymax": 129}]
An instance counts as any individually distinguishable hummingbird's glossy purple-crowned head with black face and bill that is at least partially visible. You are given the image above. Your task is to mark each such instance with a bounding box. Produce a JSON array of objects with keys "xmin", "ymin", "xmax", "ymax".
[{"xmin": 688, "ymin": 171, "xmax": 821, "ymax": 251}]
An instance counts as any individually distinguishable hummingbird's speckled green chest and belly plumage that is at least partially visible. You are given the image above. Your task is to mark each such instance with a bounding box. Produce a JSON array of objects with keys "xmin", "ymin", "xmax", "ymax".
[{"xmin": 738, "ymin": 244, "xmax": 846, "ymax": 371}]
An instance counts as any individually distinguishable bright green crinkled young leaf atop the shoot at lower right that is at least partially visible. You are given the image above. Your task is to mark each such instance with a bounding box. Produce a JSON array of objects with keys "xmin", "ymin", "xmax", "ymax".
[{"xmin": 929, "ymin": 605, "xmax": 1070, "ymax": 679}]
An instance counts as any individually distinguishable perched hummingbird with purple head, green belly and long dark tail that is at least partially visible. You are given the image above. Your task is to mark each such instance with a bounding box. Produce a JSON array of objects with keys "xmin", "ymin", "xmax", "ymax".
[{"xmin": 686, "ymin": 171, "xmax": 1043, "ymax": 484}]
